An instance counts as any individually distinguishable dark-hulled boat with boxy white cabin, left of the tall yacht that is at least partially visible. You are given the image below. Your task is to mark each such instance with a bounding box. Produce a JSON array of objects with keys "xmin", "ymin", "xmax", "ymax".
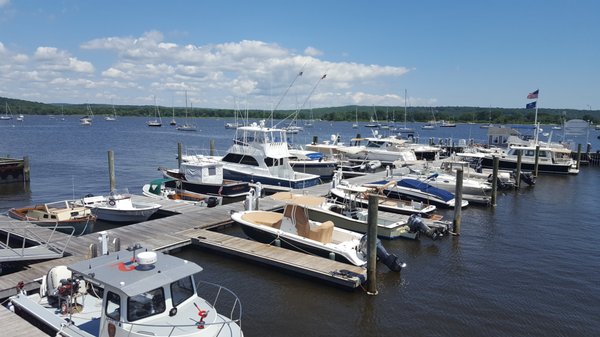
[{"xmin": 158, "ymin": 155, "xmax": 250, "ymax": 198}]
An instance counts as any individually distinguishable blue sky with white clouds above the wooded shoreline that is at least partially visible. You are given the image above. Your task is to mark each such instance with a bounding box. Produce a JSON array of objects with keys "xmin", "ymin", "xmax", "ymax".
[{"xmin": 0, "ymin": 0, "xmax": 600, "ymax": 110}]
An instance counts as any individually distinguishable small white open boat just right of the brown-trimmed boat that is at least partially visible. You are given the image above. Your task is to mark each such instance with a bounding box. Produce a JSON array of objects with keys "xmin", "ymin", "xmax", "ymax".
[{"xmin": 81, "ymin": 190, "xmax": 161, "ymax": 223}]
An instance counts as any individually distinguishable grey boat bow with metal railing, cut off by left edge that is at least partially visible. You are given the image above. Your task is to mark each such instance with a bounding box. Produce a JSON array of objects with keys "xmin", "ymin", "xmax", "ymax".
[{"xmin": 0, "ymin": 221, "xmax": 75, "ymax": 262}]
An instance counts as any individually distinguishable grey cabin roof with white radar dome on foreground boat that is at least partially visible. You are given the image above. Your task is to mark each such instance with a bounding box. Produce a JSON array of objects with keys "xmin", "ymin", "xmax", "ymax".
[{"xmin": 68, "ymin": 246, "xmax": 202, "ymax": 296}]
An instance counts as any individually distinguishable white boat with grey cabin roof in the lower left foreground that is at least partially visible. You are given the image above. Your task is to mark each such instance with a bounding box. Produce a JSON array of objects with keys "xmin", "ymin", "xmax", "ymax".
[{"xmin": 10, "ymin": 245, "xmax": 243, "ymax": 337}]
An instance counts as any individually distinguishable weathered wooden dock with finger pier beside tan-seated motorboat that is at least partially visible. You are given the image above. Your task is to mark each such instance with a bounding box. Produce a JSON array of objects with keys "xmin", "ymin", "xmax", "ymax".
[{"xmin": 0, "ymin": 176, "xmax": 382, "ymax": 299}]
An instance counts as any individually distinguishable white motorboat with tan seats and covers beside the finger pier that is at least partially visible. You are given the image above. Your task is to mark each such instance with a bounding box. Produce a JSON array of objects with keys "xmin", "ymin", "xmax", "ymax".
[{"xmin": 231, "ymin": 198, "xmax": 406, "ymax": 272}]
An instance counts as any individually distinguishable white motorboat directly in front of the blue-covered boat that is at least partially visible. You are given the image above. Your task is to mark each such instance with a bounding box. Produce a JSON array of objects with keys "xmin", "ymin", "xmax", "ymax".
[{"xmin": 329, "ymin": 178, "xmax": 437, "ymax": 218}]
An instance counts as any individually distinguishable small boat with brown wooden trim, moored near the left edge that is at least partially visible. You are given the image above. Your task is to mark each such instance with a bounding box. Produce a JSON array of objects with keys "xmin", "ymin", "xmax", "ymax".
[{"xmin": 8, "ymin": 200, "xmax": 96, "ymax": 235}]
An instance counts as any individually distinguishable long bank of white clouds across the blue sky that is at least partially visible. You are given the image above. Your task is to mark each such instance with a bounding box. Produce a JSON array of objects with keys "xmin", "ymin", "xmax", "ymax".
[{"xmin": 0, "ymin": 31, "xmax": 410, "ymax": 109}]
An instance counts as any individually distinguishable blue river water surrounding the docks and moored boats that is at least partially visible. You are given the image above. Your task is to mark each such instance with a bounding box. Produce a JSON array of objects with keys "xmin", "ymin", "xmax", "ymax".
[{"xmin": 0, "ymin": 116, "xmax": 600, "ymax": 336}]
